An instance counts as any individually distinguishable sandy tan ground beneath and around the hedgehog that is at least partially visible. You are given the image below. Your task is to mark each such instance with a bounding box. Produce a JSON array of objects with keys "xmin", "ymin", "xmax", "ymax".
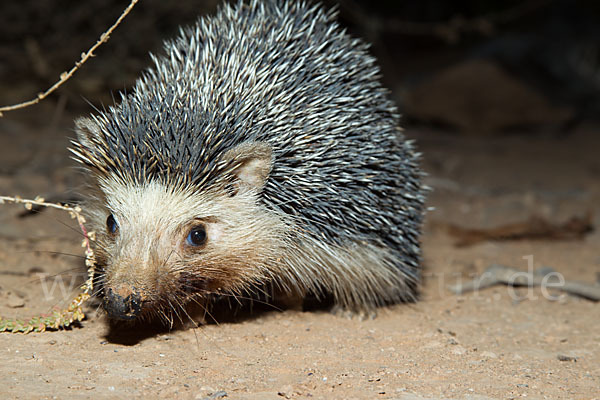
[{"xmin": 0, "ymin": 106, "xmax": 600, "ymax": 400}]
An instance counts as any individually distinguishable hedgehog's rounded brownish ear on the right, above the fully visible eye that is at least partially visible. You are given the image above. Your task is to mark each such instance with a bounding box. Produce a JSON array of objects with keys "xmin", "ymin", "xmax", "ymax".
[{"xmin": 223, "ymin": 142, "xmax": 273, "ymax": 190}]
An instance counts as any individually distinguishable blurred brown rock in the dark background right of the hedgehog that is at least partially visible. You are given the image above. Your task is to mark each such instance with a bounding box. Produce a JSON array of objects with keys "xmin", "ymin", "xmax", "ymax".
[{"xmin": 404, "ymin": 60, "xmax": 574, "ymax": 134}]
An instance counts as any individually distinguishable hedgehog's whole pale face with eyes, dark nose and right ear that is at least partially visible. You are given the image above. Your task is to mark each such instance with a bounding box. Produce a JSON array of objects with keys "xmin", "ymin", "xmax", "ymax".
[{"xmin": 92, "ymin": 144, "xmax": 285, "ymax": 321}]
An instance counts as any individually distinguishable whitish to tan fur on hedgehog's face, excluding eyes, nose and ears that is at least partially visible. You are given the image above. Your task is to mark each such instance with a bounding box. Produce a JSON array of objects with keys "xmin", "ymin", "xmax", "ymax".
[{"xmin": 91, "ymin": 181, "xmax": 286, "ymax": 304}]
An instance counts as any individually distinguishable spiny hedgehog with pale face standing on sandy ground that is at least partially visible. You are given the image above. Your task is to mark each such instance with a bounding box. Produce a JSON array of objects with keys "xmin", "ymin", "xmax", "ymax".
[{"xmin": 70, "ymin": 0, "xmax": 427, "ymax": 322}]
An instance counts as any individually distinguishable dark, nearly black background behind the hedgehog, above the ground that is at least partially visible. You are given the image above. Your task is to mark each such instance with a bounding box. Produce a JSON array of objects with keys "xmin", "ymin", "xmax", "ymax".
[{"xmin": 0, "ymin": 0, "xmax": 600, "ymax": 134}]
